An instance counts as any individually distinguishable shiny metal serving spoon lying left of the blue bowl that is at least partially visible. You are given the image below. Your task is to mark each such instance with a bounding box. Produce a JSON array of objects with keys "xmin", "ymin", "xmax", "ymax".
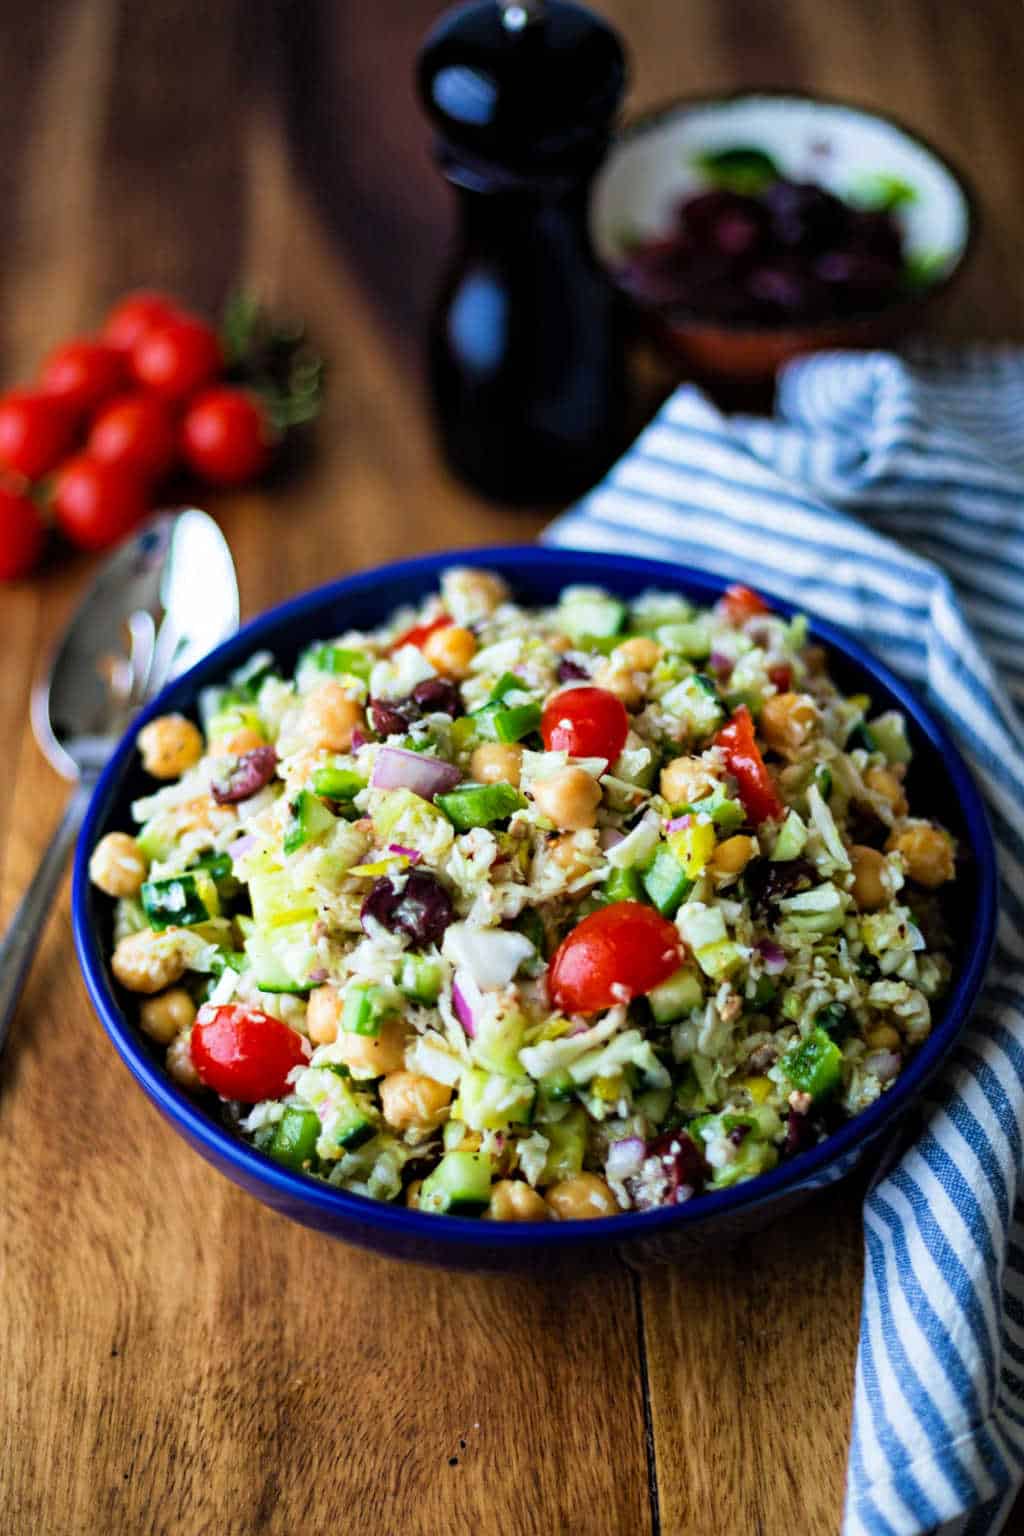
[{"xmin": 0, "ymin": 507, "xmax": 238, "ymax": 1052}]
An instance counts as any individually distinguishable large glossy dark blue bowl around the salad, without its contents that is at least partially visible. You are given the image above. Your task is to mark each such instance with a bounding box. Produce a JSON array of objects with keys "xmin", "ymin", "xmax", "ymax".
[{"xmin": 72, "ymin": 545, "xmax": 996, "ymax": 1269}]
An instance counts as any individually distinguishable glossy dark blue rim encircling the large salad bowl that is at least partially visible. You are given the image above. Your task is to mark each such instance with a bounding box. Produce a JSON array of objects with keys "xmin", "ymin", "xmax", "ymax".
[{"xmin": 71, "ymin": 545, "xmax": 996, "ymax": 1253}]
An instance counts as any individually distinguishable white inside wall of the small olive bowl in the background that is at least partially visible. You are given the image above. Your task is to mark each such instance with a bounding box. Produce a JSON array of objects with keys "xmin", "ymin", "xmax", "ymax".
[{"xmin": 591, "ymin": 95, "xmax": 970, "ymax": 281}]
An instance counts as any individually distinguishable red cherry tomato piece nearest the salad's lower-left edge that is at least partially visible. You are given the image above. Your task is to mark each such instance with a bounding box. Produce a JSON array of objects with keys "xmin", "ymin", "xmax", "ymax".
[{"xmin": 189, "ymin": 1003, "xmax": 307, "ymax": 1104}]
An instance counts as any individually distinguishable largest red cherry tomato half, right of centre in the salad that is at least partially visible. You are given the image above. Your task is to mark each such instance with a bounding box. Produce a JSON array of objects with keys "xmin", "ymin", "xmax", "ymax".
[{"xmin": 548, "ymin": 902, "xmax": 686, "ymax": 1014}]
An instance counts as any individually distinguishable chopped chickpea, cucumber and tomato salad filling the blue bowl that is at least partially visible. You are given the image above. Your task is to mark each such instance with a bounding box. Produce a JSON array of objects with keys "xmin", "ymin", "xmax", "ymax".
[{"xmin": 89, "ymin": 567, "xmax": 958, "ymax": 1221}]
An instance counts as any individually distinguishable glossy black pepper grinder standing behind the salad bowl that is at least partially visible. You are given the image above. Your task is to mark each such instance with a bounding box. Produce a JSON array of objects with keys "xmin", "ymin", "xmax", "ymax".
[{"xmin": 419, "ymin": 0, "xmax": 626, "ymax": 502}]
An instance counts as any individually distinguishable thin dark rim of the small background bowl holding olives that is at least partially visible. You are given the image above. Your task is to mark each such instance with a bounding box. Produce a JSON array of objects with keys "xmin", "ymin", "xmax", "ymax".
[{"xmin": 591, "ymin": 86, "xmax": 981, "ymax": 338}]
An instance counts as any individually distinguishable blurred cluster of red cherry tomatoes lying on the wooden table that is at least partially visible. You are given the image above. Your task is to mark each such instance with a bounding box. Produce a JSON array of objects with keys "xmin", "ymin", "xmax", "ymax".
[{"xmin": 0, "ymin": 292, "xmax": 296, "ymax": 581}]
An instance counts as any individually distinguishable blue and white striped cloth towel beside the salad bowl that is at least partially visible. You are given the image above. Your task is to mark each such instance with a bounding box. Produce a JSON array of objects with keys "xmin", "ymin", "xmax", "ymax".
[{"xmin": 547, "ymin": 349, "xmax": 1024, "ymax": 1536}]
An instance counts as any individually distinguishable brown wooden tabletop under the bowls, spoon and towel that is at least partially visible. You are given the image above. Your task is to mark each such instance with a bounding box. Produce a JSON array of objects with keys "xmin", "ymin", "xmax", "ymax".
[{"xmin": 0, "ymin": 0, "xmax": 1024, "ymax": 1536}]
